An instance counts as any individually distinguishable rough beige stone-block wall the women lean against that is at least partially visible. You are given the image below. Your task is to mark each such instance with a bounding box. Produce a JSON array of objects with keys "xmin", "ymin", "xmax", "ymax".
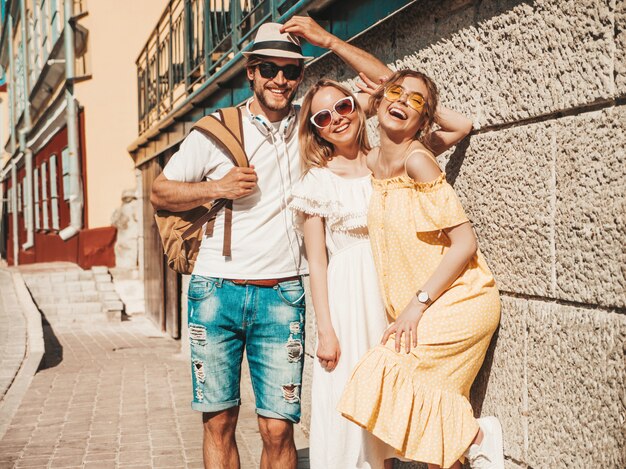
[{"xmin": 302, "ymin": 0, "xmax": 626, "ymax": 468}]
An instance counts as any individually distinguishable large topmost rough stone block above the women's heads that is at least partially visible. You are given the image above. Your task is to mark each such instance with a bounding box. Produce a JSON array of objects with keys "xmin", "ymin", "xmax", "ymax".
[{"xmin": 305, "ymin": 0, "xmax": 626, "ymax": 127}]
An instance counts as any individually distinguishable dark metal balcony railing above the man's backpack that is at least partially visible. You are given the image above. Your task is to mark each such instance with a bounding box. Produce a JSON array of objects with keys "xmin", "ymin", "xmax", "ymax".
[{"xmin": 137, "ymin": 0, "xmax": 300, "ymax": 135}]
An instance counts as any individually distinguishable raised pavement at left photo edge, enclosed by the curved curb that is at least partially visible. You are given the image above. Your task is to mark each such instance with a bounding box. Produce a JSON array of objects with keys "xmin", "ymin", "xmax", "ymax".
[{"xmin": 0, "ymin": 269, "xmax": 26, "ymax": 401}]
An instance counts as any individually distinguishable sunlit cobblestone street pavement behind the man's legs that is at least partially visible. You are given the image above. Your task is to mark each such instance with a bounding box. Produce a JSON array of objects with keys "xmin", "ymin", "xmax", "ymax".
[{"xmin": 0, "ymin": 308, "xmax": 308, "ymax": 469}]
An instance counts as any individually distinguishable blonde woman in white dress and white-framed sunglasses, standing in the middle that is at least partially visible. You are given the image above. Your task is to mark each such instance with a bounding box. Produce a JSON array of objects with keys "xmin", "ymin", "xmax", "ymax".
[{"xmin": 290, "ymin": 76, "xmax": 471, "ymax": 469}]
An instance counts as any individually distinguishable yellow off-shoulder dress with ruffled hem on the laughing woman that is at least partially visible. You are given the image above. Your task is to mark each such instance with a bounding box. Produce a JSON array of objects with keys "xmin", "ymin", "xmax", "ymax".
[{"xmin": 338, "ymin": 163, "xmax": 500, "ymax": 468}]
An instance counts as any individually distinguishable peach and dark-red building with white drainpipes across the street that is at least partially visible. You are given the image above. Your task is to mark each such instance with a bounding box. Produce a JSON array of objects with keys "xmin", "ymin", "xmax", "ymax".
[{"xmin": 0, "ymin": 0, "xmax": 162, "ymax": 268}]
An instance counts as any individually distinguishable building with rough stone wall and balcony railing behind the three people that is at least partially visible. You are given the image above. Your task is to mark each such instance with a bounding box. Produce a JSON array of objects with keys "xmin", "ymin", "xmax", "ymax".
[{"xmin": 129, "ymin": 0, "xmax": 626, "ymax": 469}]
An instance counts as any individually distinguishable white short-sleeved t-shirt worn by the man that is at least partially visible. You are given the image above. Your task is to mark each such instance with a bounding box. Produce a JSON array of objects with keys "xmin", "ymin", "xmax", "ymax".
[{"xmin": 163, "ymin": 110, "xmax": 307, "ymax": 280}]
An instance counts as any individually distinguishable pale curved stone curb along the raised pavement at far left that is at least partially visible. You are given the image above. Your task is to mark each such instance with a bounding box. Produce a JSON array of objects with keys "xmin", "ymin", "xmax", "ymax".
[{"xmin": 0, "ymin": 269, "xmax": 45, "ymax": 440}]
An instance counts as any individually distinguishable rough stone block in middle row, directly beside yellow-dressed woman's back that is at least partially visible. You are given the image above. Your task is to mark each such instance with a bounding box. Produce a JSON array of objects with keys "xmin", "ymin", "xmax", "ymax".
[{"xmin": 445, "ymin": 123, "xmax": 554, "ymax": 296}]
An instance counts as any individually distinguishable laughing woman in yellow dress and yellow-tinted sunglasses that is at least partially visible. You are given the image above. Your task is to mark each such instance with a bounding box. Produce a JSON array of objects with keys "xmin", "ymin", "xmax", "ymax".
[{"xmin": 338, "ymin": 70, "xmax": 504, "ymax": 469}]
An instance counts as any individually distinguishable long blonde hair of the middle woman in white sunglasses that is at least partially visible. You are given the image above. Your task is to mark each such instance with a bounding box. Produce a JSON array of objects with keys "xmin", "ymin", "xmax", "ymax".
[{"xmin": 298, "ymin": 80, "xmax": 371, "ymax": 173}]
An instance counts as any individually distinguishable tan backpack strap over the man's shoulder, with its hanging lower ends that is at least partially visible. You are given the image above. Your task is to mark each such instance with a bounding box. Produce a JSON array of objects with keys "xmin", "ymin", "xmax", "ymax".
[{"xmin": 183, "ymin": 107, "xmax": 250, "ymax": 257}]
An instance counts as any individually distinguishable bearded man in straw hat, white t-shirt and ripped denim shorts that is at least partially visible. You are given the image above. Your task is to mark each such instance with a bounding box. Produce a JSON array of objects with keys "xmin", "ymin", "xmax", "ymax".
[{"xmin": 151, "ymin": 17, "xmax": 388, "ymax": 469}]
